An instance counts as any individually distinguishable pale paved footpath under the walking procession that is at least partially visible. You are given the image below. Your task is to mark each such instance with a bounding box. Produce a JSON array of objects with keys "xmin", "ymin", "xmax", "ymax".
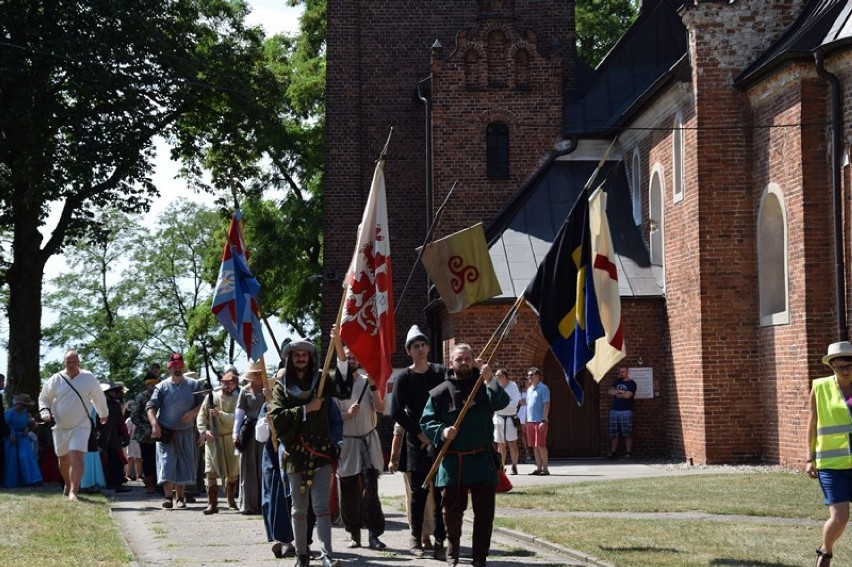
[{"xmin": 108, "ymin": 460, "xmax": 718, "ymax": 567}]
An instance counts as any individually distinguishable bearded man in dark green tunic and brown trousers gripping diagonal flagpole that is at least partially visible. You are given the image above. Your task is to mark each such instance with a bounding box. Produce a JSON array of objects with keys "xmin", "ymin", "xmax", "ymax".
[{"xmin": 420, "ymin": 343, "xmax": 509, "ymax": 567}]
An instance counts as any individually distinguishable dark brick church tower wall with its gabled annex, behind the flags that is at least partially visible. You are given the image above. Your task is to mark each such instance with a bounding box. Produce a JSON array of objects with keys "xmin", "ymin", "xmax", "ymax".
[{"xmin": 322, "ymin": 0, "xmax": 573, "ymax": 366}]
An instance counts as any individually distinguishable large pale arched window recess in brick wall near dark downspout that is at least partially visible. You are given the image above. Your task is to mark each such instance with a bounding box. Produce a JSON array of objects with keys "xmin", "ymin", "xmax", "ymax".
[{"xmin": 757, "ymin": 183, "xmax": 790, "ymax": 326}]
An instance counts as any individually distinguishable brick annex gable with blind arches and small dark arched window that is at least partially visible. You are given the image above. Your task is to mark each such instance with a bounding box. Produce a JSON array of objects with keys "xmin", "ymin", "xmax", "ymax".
[{"xmin": 432, "ymin": 2, "xmax": 568, "ymax": 236}]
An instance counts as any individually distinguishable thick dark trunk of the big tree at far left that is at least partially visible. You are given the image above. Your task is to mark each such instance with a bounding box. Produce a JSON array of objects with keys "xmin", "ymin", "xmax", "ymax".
[{"xmin": 6, "ymin": 211, "xmax": 45, "ymax": 399}]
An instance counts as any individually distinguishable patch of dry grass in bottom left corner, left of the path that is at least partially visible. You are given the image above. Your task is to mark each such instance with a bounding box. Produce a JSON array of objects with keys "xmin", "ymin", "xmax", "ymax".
[{"xmin": 0, "ymin": 487, "xmax": 131, "ymax": 567}]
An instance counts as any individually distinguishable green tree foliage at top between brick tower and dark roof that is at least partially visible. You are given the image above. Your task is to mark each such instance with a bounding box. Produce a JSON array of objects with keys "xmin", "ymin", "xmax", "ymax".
[{"xmin": 574, "ymin": 0, "xmax": 636, "ymax": 67}]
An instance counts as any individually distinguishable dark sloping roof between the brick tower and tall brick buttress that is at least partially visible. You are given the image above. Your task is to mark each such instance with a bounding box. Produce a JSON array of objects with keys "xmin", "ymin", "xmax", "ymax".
[{"xmin": 563, "ymin": 0, "xmax": 689, "ymax": 137}]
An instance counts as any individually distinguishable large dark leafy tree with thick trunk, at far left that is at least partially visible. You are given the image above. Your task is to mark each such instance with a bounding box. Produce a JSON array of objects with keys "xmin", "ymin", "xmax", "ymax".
[{"xmin": 0, "ymin": 0, "xmax": 292, "ymax": 395}]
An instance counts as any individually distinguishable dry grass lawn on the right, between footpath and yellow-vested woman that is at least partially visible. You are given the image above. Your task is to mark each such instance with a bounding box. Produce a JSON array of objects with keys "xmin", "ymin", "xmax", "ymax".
[{"xmin": 495, "ymin": 472, "xmax": 840, "ymax": 567}]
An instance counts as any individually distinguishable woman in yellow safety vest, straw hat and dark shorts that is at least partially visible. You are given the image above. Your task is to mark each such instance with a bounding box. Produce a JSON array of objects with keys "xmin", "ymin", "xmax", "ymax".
[{"xmin": 805, "ymin": 341, "xmax": 852, "ymax": 567}]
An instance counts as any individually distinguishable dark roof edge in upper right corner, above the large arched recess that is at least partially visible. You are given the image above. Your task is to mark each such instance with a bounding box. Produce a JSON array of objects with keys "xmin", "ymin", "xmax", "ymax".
[{"xmin": 735, "ymin": 0, "xmax": 852, "ymax": 86}]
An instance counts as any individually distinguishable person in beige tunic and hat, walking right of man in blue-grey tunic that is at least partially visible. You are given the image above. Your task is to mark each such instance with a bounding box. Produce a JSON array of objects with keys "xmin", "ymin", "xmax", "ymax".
[{"xmin": 196, "ymin": 372, "xmax": 240, "ymax": 514}]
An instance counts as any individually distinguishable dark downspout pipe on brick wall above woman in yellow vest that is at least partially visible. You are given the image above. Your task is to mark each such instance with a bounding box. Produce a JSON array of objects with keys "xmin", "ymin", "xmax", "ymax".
[{"xmin": 814, "ymin": 50, "xmax": 849, "ymax": 341}]
